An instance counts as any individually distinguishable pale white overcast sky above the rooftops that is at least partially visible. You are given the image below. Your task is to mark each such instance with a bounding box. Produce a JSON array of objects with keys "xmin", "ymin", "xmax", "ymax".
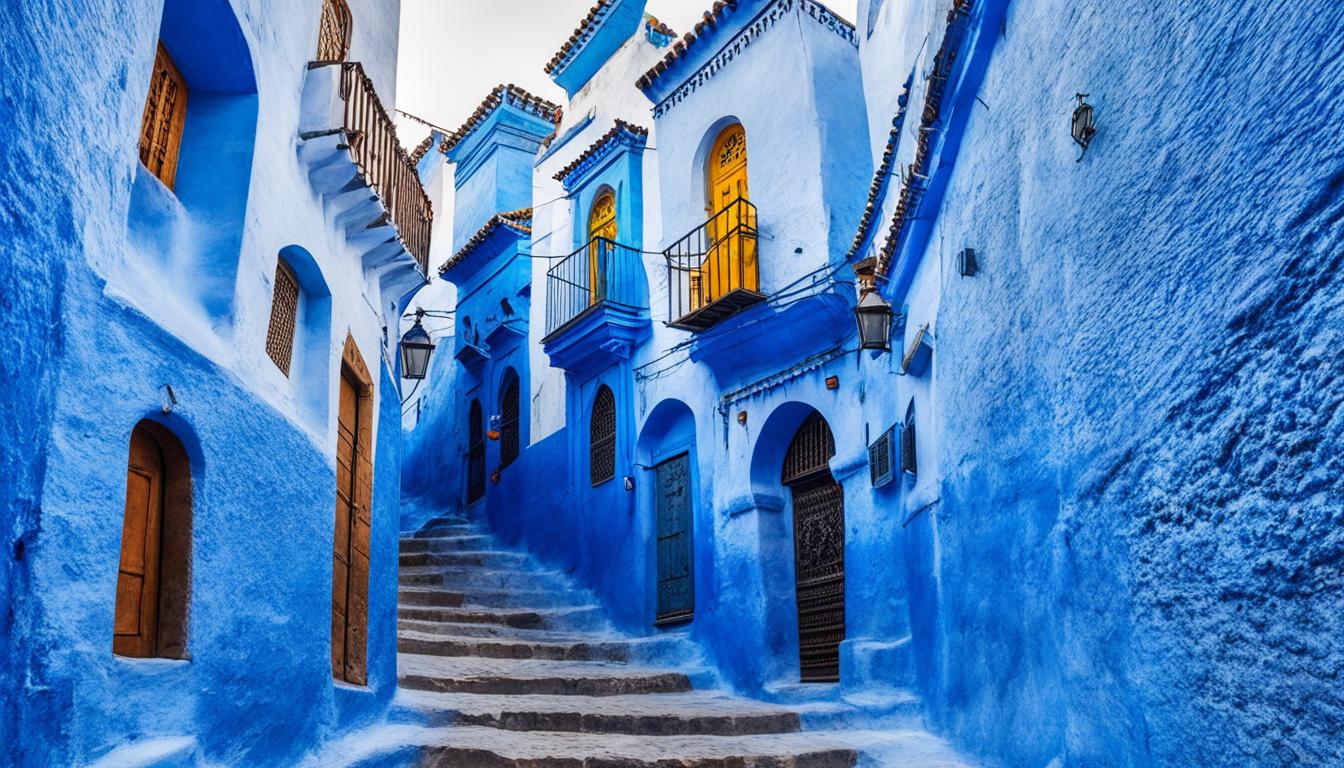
[{"xmin": 396, "ymin": 0, "xmax": 857, "ymax": 147}]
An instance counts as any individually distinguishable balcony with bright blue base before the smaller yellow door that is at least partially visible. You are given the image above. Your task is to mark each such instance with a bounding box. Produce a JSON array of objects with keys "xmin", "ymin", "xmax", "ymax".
[{"xmin": 542, "ymin": 238, "xmax": 649, "ymax": 373}]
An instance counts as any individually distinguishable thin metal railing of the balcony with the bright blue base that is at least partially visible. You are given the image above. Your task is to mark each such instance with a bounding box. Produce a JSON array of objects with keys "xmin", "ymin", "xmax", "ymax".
[{"xmin": 546, "ymin": 237, "xmax": 644, "ymax": 336}]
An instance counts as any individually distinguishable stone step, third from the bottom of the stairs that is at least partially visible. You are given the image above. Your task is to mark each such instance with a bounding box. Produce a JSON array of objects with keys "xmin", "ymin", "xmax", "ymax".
[{"xmin": 396, "ymin": 654, "xmax": 691, "ymax": 699}]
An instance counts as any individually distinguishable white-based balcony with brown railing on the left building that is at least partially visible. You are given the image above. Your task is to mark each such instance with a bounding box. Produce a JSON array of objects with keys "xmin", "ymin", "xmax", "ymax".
[{"xmin": 298, "ymin": 62, "xmax": 434, "ymax": 280}]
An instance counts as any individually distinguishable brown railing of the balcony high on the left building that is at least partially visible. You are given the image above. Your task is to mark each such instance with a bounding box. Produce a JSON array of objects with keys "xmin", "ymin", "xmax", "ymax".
[{"xmin": 340, "ymin": 62, "xmax": 434, "ymax": 273}]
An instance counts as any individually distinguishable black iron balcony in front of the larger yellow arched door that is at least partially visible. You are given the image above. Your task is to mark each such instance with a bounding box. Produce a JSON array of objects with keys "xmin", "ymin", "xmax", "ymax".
[{"xmin": 663, "ymin": 198, "xmax": 765, "ymax": 331}]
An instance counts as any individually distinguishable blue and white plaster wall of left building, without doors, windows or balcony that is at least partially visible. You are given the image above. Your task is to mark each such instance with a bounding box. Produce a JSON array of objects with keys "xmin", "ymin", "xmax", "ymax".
[{"xmin": 0, "ymin": 0, "xmax": 414, "ymax": 765}]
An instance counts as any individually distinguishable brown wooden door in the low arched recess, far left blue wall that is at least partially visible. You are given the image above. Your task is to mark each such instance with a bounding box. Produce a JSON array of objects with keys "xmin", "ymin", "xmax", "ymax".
[{"xmin": 112, "ymin": 426, "xmax": 164, "ymax": 656}]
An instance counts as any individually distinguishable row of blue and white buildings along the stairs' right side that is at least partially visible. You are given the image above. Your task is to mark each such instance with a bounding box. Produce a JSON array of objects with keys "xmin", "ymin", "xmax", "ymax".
[{"xmin": 407, "ymin": 0, "xmax": 1344, "ymax": 767}]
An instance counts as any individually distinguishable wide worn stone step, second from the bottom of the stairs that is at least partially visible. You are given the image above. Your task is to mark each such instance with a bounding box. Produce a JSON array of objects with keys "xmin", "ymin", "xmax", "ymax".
[{"xmin": 394, "ymin": 689, "xmax": 801, "ymax": 736}]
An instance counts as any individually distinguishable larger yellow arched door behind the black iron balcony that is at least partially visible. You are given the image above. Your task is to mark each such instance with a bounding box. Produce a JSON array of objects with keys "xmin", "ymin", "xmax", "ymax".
[{"xmin": 691, "ymin": 124, "xmax": 759, "ymax": 308}]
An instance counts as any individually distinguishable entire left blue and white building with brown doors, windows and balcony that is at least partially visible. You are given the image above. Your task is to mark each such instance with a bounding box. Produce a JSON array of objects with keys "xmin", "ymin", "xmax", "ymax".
[{"xmin": 0, "ymin": 0, "xmax": 431, "ymax": 765}]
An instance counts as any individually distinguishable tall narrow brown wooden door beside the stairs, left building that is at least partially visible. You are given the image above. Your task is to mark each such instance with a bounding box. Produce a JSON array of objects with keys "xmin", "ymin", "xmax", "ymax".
[{"xmin": 332, "ymin": 370, "xmax": 370, "ymax": 685}]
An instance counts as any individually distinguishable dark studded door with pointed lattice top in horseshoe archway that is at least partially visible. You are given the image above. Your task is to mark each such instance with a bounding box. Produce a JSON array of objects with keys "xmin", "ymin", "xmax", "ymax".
[{"xmin": 781, "ymin": 412, "xmax": 844, "ymax": 682}]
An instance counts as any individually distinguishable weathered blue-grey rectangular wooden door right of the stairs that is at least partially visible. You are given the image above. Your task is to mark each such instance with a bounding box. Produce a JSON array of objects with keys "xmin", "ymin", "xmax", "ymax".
[{"xmin": 655, "ymin": 453, "xmax": 695, "ymax": 624}]
